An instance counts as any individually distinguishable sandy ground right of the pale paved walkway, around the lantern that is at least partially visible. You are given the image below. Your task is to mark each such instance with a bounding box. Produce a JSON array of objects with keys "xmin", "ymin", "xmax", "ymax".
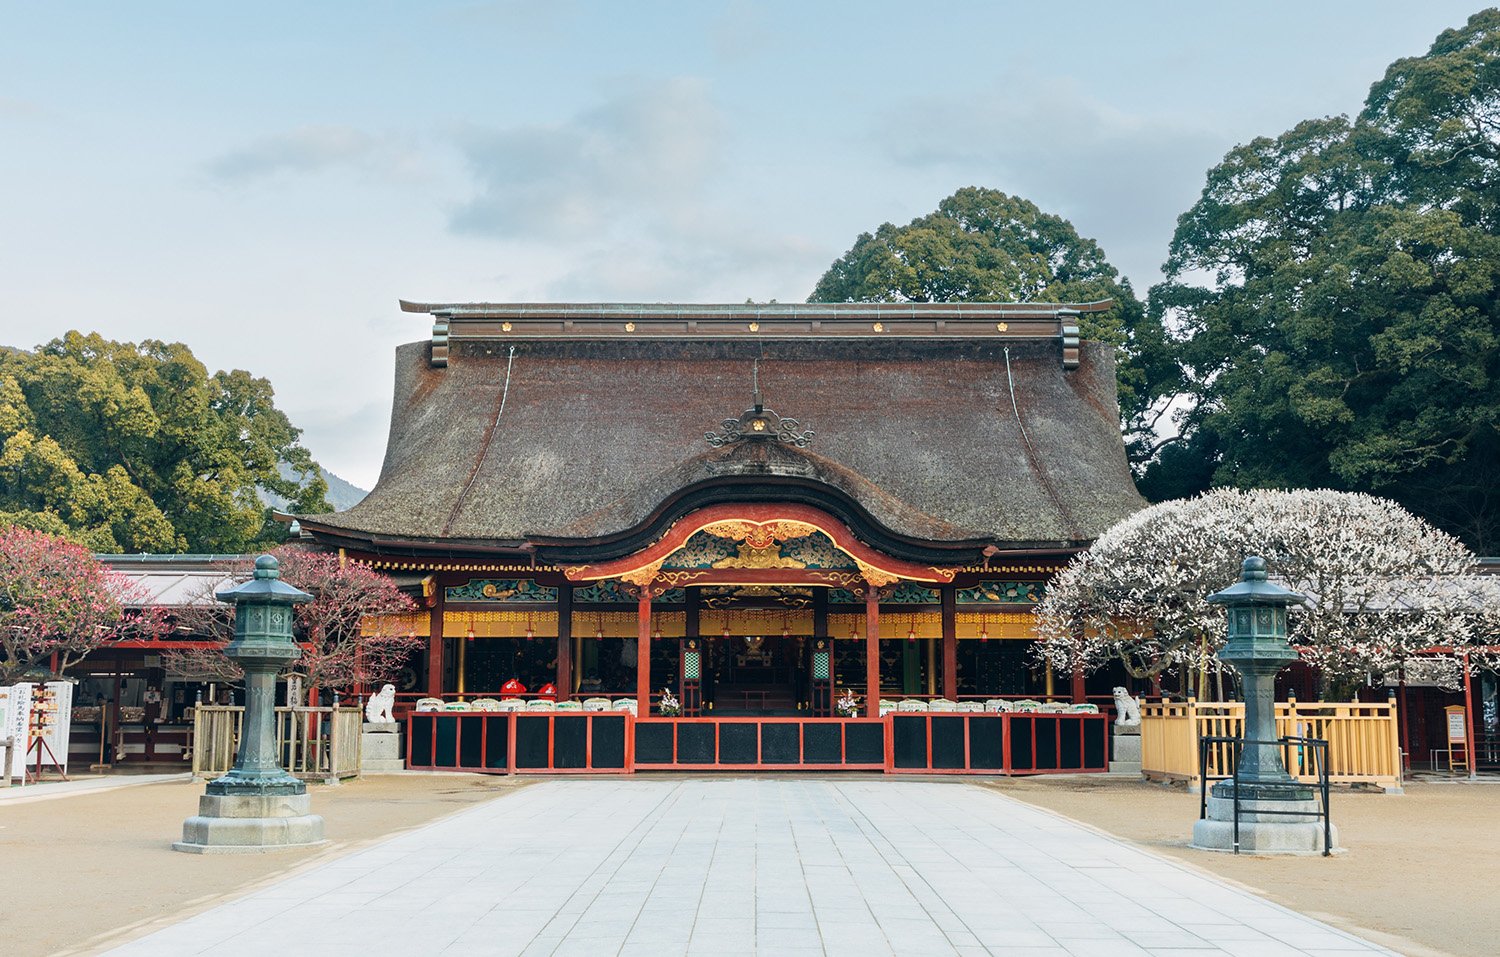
[{"xmin": 989, "ymin": 776, "xmax": 1500, "ymax": 957}]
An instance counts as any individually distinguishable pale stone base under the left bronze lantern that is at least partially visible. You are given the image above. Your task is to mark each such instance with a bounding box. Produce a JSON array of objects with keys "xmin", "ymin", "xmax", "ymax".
[{"xmin": 173, "ymin": 794, "xmax": 329, "ymax": 854}]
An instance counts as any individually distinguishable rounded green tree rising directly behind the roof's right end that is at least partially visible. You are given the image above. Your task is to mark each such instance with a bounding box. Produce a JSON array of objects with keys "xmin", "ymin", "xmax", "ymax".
[{"xmin": 809, "ymin": 186, "xmax": 1176, "ymax": 455}]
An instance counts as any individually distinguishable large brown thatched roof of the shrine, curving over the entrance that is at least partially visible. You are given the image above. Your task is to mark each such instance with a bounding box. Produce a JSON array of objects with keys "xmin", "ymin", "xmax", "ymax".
[{"xmin": 302, "ymin": 308, "xmax": 1143, "ymax": 558}]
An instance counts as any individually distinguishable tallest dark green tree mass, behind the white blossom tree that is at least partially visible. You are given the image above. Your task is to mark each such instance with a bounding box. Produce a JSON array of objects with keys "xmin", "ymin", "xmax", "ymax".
[{"xmin": 1143, "ymin": 9, "xmax": 1500, "ymax": 552}]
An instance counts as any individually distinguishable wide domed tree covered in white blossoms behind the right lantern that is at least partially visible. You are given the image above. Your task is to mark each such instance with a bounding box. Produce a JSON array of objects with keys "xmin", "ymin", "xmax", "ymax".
[{"xmin": 1037, "ymin": 489, "xmax": 1500, "ymax": 693}]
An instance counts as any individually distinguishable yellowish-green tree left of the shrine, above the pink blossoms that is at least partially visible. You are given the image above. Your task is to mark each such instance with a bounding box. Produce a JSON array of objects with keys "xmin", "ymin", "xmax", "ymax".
[{"xmin": 0, "ymin": 332, "xmax": 327, "ymax": 552}]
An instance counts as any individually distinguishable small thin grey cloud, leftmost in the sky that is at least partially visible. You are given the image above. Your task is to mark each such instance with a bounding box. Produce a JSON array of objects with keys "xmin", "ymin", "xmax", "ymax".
[{"xmin": 207, "ymin": 126, "xmax": 411, "ymax": 183}]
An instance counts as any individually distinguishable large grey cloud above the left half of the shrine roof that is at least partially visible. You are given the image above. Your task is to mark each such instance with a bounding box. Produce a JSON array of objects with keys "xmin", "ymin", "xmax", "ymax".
[{"xmin": 452, "ymin": 78, "xmax": 723, "ymax": 240}]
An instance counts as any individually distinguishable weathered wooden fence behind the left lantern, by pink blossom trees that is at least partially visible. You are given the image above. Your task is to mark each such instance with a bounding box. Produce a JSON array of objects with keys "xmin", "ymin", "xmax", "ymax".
[{"xmin": 192, "ymin": 705, "xmax": 365, "ymax": 783}]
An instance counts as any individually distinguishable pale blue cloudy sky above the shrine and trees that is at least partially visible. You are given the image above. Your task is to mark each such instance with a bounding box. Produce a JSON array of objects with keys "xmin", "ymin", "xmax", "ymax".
[{"xmin": 0, "ymin": 0, "xmax": 1481, "ymax": 489}]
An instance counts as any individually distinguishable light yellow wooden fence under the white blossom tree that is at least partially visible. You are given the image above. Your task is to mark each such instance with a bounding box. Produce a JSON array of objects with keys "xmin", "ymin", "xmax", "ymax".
[{"xmin": 1140, "ymin": 698, "xmax": 1401, "ymax": 791}]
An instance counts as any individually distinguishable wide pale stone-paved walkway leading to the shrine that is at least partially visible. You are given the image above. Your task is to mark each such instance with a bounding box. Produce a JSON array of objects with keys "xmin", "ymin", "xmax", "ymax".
[{"xmin": 113, "ymin": 777, "xmax": 1389, "ymax": 957}]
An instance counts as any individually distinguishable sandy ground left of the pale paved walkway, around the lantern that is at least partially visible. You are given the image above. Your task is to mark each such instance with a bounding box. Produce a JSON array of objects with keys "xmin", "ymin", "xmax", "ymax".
[{"xmin": 0, "ymin": 774, "xmax": 525, "ymax": 957}]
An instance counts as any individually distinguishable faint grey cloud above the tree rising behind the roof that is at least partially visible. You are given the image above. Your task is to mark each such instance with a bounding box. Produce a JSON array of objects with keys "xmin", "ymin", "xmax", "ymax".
[{"xmin": 876, "ymin": 77, "xmax": 1230, "ymax": 291}]
